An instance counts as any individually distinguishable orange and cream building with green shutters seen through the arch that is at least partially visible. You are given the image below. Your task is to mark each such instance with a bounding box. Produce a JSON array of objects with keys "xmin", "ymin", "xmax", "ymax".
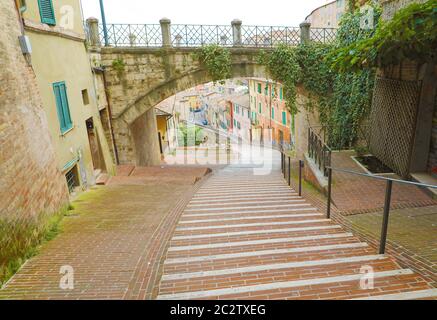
[{"xmin": 249, "ymin": 78, "xmax": 295, "ymax": 145}]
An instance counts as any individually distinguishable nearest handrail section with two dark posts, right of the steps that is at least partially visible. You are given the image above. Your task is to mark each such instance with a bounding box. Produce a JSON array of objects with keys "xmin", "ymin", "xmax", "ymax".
[{"xmin": 326, "ymin": 166, "xmax": 437, "ymax": 254}]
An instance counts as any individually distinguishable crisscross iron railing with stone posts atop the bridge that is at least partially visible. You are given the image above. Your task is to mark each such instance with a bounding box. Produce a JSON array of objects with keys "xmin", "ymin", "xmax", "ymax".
[{"xmin": 92, "ymin": 22, "xmax": 336, "ymax": 48}]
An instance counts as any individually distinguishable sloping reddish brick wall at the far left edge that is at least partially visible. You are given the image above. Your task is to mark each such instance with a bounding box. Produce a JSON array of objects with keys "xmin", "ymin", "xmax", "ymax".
[{"xmin": 0, "ymin": 0, "xmax": 68, "ymax": 221}]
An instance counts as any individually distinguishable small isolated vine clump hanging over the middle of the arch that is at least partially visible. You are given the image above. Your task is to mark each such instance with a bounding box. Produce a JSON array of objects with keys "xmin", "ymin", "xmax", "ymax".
[{"xmin": 197, "ymin": 45, "xmax": 232, "ymax": 82}]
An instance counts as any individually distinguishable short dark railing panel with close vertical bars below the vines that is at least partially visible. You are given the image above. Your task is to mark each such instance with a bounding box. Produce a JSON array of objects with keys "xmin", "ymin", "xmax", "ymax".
[{"xmin": 308, "ymin": 127, "xmax": 332, "ymax": 177}]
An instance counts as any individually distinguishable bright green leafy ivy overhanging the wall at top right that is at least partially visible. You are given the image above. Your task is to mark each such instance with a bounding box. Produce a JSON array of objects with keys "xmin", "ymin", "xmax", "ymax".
[{"xmin": 332, "ymin": 0, "xmax": 437, "ymax": 71}]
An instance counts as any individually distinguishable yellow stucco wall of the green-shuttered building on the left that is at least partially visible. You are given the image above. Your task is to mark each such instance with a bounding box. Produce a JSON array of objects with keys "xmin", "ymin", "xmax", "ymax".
[{"xmin": 24, "ymin": 0, "xmax": 114, "ymax": 185}]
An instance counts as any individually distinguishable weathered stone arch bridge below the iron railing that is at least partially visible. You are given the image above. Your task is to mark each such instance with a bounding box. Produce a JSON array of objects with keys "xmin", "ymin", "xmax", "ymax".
[{"xmin": 101, "ymin": 48, "xmax": 310, "ymax": 166}]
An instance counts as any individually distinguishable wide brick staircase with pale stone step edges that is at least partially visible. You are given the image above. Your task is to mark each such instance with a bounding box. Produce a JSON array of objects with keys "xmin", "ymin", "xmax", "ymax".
[{"xmin": 157, "ymin": 166, "xmax": 437, "ymax": 300}]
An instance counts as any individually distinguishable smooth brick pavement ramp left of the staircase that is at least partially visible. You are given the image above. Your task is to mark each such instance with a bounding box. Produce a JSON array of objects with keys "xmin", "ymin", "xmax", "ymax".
[{"xmin": 0, "ymin": 168, "xmax": 207, "ymax": 299}]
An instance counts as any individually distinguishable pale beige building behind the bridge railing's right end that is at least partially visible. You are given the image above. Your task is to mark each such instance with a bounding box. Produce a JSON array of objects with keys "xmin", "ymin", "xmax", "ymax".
[{"xmin": 305, "ymin": 0, "xmax": 347, "ymax": 28}]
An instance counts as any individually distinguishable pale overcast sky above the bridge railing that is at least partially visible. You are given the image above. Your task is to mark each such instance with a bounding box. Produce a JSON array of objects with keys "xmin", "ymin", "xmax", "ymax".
[{"xmin": 82, "ymin": 0, "xmax": 331, "ymax": 26}]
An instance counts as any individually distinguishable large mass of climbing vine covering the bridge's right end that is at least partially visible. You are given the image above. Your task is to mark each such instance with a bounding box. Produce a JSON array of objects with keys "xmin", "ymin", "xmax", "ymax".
[{"xmin": 260, "ymin": 8, "xmax": 380, "ymax": 148}]
